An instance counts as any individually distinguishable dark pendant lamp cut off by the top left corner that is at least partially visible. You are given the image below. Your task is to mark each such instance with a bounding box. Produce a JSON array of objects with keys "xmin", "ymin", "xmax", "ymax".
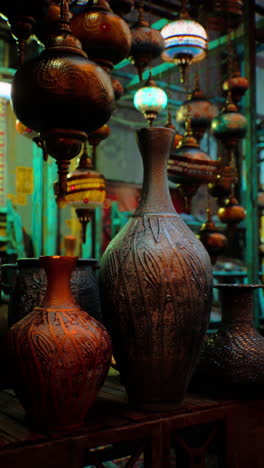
[{"xmin": 0, "ymin": 0, "xmax": 48, "ymax": 64}]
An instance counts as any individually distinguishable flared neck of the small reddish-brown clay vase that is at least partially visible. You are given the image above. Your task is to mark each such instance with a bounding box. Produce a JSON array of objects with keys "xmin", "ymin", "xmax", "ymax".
[{"xmin": 40, "ymin": 256, "xmax": 79, "ymax": 310}]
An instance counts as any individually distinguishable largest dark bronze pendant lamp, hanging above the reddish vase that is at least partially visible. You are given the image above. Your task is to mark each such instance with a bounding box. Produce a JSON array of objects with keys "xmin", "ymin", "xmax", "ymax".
[{"xmin": 12, "ymin": 0, "xmax": 114, "ymax": 196}]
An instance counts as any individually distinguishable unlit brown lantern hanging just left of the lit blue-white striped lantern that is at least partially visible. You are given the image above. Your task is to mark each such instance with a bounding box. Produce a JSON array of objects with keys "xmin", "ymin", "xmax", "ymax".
[{"xmin": 130, "ymin": 7, "xmax": 165, "ymax": 80}]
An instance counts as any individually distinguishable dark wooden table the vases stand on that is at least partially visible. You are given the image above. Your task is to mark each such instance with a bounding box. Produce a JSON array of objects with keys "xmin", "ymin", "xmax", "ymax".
[{"xmin": 0, "ymin": 380, "xmax": 264, "ymax": 468}]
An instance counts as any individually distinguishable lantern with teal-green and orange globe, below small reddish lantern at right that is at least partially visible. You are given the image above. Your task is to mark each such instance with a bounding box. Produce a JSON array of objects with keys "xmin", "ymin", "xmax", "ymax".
[{"xmin": 211, "ymin": 91, "xmax": 247, "ymax": 149}]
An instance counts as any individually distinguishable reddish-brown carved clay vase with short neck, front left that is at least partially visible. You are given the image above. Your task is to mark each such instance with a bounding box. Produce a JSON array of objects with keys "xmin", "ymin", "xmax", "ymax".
[{"xmin": 8, "ymin": 257, "xmax": 111, "ymax": 431}]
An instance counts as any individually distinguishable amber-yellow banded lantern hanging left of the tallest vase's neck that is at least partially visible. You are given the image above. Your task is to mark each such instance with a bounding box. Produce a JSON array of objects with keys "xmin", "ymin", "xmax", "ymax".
[{"xmin": 64, "ymin": 145, "xmax": 106, "ymax": 243}]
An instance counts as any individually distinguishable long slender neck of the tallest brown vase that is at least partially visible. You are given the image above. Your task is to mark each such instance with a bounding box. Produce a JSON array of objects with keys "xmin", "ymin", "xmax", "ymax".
[{"xmin": 133, "ymin": 127, "xmax": 176, "ymax": 217}]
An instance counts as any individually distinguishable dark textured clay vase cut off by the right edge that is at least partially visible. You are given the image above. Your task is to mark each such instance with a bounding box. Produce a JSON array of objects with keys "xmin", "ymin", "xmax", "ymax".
[{"xmin": 190, "ymin": 284, "xmax": 264, "ymax": 399}]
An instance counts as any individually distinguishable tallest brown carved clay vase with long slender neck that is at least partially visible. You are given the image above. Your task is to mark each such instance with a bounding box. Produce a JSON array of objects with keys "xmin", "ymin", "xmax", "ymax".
[{"xmin": 100, "ymin": 127, "xmax": 212, "ymax": 411}]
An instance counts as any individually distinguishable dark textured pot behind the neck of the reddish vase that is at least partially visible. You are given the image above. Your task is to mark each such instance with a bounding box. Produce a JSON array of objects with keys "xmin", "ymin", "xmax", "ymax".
[{"xmin": 2, "ymin": 258, "xmax": 102, "ymax": 326}]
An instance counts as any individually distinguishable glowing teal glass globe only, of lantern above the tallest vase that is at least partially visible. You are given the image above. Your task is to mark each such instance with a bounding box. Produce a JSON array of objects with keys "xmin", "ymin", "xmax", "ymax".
[{"xmin": 134, "ymin": 86, "xmax": 168, "ymax": 113}]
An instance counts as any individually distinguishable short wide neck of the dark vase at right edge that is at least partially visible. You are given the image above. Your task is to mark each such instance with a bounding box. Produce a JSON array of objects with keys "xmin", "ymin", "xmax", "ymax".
[{"xmin": 217, "ymin": 284, "xmax": 263, "ymax": 323}]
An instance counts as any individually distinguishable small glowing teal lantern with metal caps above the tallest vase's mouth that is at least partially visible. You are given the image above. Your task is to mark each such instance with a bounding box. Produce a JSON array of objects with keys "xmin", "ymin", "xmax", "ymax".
[{"xmin": 134, "ymin": 75, "xmax": 168, "ymax": 126}]
